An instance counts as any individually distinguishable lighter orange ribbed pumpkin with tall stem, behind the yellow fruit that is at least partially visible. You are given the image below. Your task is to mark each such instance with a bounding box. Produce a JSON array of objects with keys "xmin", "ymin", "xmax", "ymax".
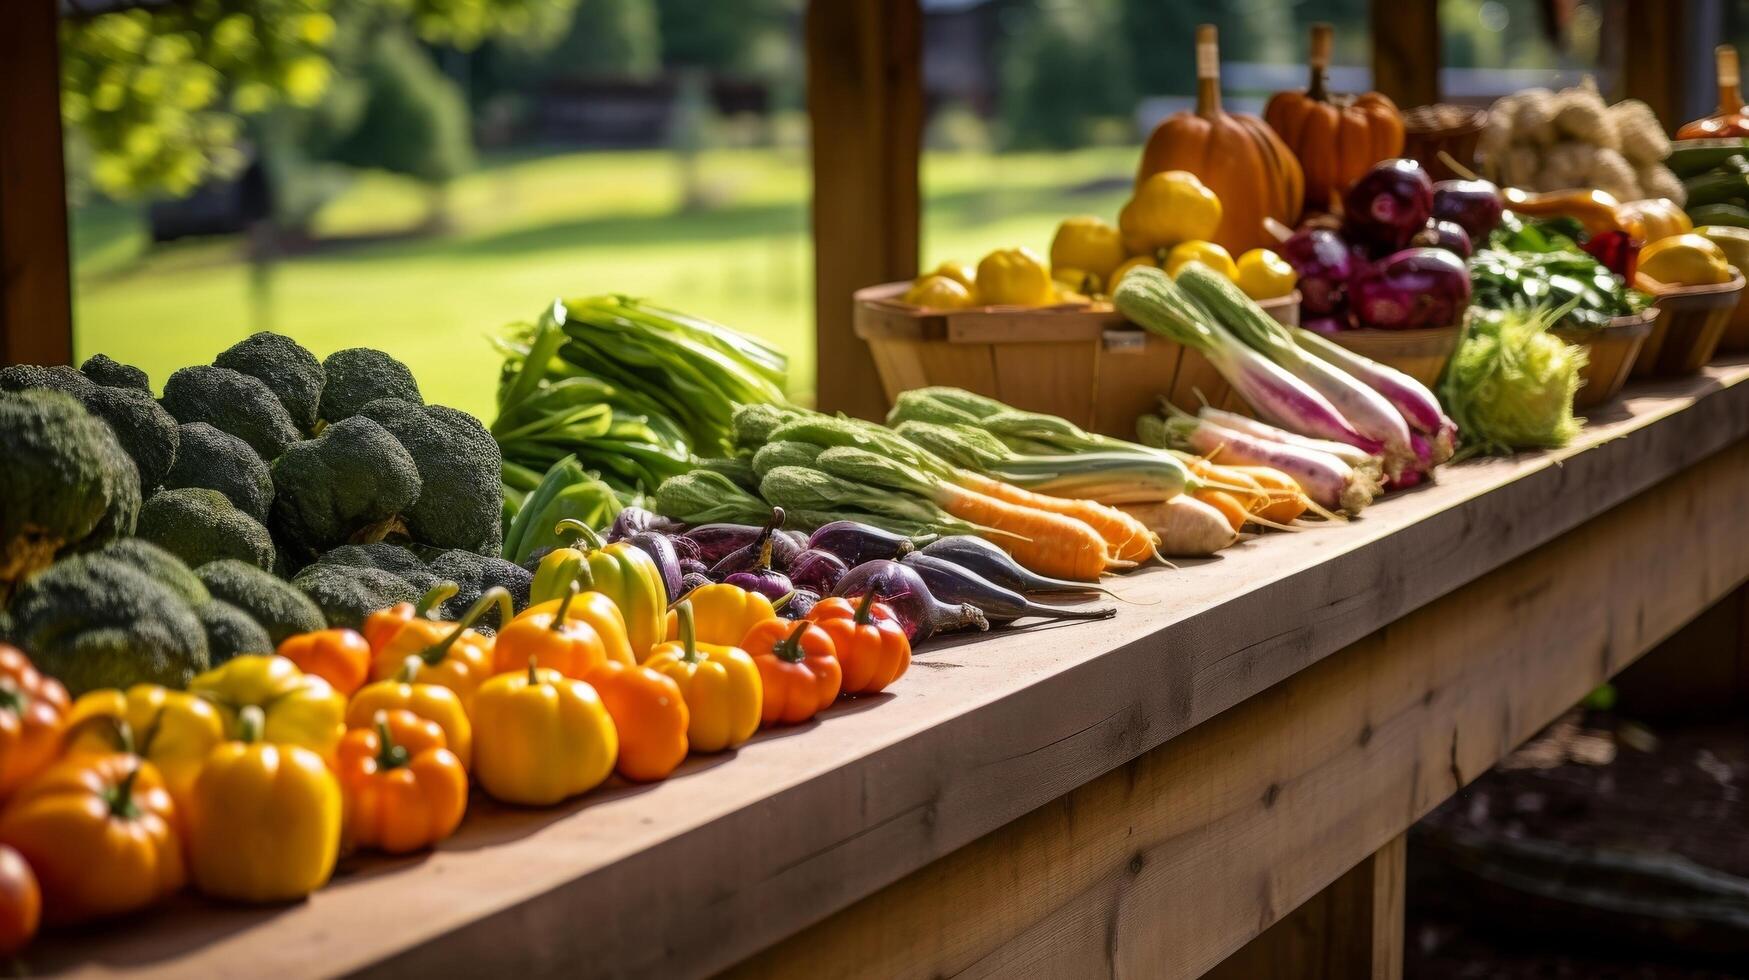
[{"xmin": 1135, "ymin": 25, "xmax": 1305, "ymax": 256}]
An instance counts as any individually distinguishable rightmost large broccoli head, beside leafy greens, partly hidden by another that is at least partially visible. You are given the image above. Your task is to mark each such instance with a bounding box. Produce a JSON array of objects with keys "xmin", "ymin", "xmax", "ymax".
[{"xmin": 359, "ymin": 399, "xmax": 504, "ymax": 555}]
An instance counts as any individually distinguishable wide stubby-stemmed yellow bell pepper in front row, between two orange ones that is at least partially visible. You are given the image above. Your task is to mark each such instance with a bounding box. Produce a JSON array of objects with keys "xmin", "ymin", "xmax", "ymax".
[{"xmin": 474, "ymin": 663, "xmax": 619, "ymax": 807}]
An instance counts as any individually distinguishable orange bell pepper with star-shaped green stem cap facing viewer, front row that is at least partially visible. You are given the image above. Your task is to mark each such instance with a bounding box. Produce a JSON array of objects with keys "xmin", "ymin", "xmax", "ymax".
[{"xmin": 339, "ymin": 709, "xmax": 467, "ymax": 854}]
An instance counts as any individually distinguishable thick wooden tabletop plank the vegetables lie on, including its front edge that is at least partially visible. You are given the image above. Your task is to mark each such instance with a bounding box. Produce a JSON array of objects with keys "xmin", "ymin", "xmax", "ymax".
[{"xmin": 31, "ymin": 361, "xmax": 1749, "ymax": 977}]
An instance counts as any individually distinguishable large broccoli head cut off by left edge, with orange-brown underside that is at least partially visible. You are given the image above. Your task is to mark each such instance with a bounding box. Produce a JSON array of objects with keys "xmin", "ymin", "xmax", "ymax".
[{"xmin": 0, "ymin": 390, "xmax": 140, "ymax": 597}]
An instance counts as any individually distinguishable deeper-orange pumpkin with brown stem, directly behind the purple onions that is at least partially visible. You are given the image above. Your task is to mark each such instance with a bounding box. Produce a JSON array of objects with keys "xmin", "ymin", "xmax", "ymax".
[{"xmin": 1263, "ymin": 25, "xmax": 1403, "ymax": 212}]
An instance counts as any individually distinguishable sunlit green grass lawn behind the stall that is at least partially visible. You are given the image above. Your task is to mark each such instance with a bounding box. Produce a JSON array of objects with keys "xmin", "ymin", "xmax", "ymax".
[{"xmin": 73, "ymin": 149, "xmax": 1135, "ymax": 420}]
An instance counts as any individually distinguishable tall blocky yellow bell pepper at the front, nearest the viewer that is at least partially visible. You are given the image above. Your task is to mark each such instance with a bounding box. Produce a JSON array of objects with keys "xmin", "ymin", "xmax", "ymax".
[{"xmin": 189, "ymin": 703, "xmax": 341, "ymax": 901}]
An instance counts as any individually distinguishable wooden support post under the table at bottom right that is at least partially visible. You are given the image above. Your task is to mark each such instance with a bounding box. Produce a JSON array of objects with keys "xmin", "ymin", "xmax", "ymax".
[{"xmin": 1203, "ymin": 835, "xmax": 1406, "ymax": 980}]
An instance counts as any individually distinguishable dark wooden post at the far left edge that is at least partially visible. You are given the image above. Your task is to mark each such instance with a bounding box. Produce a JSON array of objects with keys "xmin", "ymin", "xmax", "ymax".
[{"xmin": 0, "ymin": 0, "xmax": 73, "ymax": 364}]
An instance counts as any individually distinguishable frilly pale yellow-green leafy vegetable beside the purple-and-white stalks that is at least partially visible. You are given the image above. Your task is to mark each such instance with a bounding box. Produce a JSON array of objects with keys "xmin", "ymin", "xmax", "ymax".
[{"xmin": 1439, "ymin": 306, "xmax": 1585, "ymax": 457}]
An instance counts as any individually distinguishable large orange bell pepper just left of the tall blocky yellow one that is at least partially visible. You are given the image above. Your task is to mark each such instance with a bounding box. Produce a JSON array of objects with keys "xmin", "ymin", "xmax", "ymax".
[{"xmin": 0, "ymin": 753, "xmax": 187, "ymax": 924}]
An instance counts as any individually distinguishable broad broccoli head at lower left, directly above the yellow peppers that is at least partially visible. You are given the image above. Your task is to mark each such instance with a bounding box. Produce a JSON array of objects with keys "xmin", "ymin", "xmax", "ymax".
[{"xmin": 9, "ymin": 550, "xmax": 208, "ymax": 697}]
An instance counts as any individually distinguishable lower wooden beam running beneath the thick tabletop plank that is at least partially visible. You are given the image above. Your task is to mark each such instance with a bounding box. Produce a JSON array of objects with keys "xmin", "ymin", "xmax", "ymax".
[{"xmin": 736, "ymin": 441, "xmax": 1749, "ymax": 978}]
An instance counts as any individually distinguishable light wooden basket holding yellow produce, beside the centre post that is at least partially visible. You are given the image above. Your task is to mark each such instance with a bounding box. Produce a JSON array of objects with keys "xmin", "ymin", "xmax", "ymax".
[{"xmin": 855, "ymin": 282, "xmax": 1300, "ymax": 438}]
